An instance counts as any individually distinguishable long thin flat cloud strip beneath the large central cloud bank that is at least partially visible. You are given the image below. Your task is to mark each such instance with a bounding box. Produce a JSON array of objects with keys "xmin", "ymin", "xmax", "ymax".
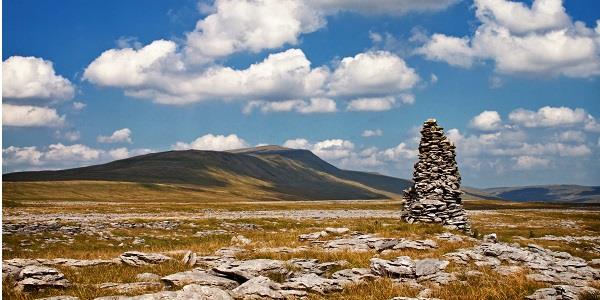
[{"xmin": 243, "ymin": 98, "xmax": 337, "ymax": 114}]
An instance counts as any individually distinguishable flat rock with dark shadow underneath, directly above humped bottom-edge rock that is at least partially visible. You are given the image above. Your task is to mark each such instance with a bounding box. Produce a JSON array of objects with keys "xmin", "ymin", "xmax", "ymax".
[{"xmin": 213, "ymin": 259, "xmax": 287, "ymax": 282}]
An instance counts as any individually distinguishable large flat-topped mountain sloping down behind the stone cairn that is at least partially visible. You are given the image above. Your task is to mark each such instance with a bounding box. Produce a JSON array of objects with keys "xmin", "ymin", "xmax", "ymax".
[{"xmin": 3, "ymin": 146, "xmax": 410, "ymax": 200}]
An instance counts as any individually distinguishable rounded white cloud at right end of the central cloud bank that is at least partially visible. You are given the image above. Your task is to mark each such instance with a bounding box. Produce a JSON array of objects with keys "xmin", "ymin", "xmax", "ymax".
[{"xmin": 328, "ymin": 51, "xmax": 419, "ymax": 96}]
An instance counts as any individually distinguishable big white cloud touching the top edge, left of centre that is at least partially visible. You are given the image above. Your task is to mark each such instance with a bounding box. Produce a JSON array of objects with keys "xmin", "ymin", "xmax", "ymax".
[{"xmin": 184, "ymin": 0, "xmax": 325, "ymax": 63}]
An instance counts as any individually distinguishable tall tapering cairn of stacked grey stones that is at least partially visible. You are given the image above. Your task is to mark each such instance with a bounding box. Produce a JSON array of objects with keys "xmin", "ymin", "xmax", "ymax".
[{"xmin": 403, "ymin": 119, "xmax": 470, "ymax": 232}]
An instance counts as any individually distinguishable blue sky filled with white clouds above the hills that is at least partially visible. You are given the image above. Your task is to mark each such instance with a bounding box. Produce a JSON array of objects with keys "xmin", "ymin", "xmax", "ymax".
[{"xmin": 2, "ymin": 0, "xmax": 600, "ymax": 187}]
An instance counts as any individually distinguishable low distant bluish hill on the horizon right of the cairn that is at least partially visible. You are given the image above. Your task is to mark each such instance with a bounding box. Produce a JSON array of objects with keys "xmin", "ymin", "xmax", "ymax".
[{"xmin": 480, "ymin": 185, "xmax": 600, "ymax": 203}]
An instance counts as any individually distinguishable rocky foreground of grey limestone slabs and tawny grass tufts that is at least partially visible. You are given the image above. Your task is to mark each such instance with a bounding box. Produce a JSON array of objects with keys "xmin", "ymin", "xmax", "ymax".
[{"xmin": 2, "ymin": 204, "xmax": 600, "ymax": 300}]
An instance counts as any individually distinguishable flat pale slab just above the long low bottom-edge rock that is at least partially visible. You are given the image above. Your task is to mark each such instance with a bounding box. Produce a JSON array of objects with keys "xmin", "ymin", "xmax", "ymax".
[{"xmin": 161, "ymin": 269, "xmax": 239, "ymax": 290}]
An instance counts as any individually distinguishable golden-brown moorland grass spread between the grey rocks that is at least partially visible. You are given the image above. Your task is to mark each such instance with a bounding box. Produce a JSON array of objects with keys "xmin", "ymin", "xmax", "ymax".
[{"xmin": 2, "ymin": 182, "xmax": 600, "ymax": 300}]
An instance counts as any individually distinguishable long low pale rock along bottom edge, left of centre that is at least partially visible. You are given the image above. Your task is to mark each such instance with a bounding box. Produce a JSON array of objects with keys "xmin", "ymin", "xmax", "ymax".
[{"xmin": 96, "ymin": 284, "xmax": 233, "ymax": 300}]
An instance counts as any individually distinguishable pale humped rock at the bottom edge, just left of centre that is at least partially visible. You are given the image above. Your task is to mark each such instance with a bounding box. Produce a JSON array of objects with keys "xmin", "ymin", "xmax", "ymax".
[{"xmin": 231, "ymin": 276, "xmax": 285, "ymax": 300}]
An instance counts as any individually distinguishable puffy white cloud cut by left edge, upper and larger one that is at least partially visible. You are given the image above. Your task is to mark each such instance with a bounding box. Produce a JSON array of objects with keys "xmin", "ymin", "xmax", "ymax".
[{"xmin": 2, "ymin": 56, "xmax": 75, "ymax": 100}]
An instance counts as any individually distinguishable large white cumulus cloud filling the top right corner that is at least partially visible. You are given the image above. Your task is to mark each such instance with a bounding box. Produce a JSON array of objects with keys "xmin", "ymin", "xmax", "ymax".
[{"xmin": 417, "ymin": 0, "xmax": 600, "ymax": 77}]
